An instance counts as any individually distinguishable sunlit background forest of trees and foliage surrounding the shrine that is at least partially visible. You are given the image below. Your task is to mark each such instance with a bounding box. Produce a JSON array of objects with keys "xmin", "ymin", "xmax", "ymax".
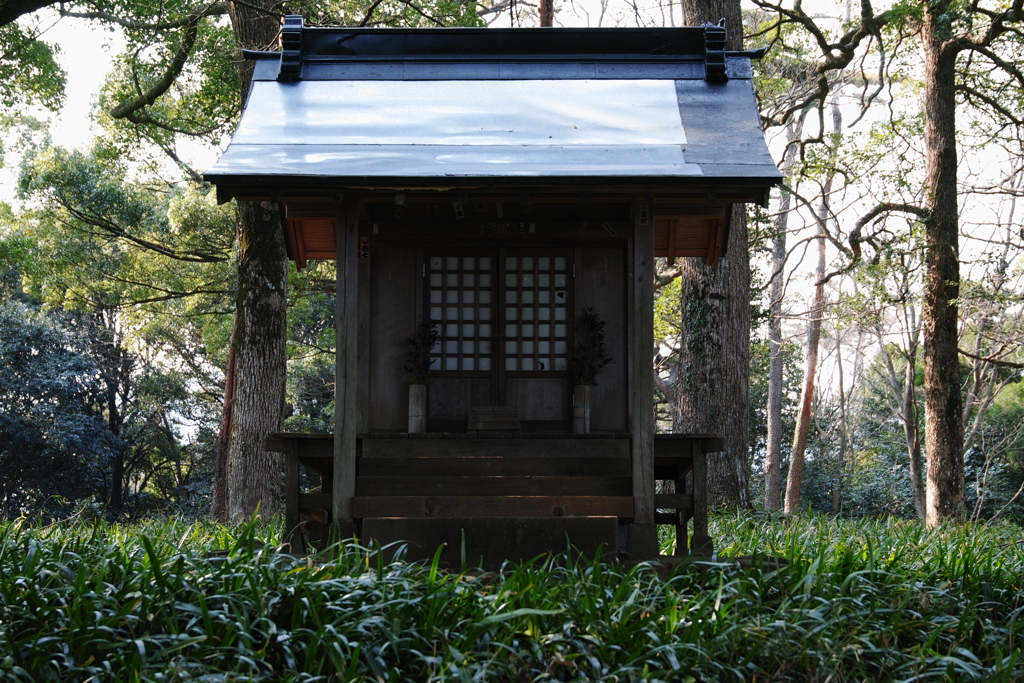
[{"xmin": 0, "ymin": 0, "xmax": 1024, "ymax": 522}]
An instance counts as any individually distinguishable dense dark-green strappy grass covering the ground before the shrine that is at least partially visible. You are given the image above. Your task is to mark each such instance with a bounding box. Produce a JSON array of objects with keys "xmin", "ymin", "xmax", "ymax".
[{"xmin": 0, "ymin": 513, "xmax": 1024, "ymax": 681}]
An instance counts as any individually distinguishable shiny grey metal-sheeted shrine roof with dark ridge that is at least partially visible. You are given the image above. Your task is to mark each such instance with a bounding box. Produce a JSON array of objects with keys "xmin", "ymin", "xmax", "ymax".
[{"xmin": 206, "ymin": 17, "xmax": 780, "ymax": 201}]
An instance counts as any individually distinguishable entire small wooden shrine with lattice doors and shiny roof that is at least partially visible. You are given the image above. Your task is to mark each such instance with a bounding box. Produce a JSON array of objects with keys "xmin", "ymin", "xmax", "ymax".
[{"xmin": 206, "ymin": 16, "xmax": 780, "ymax": 564}]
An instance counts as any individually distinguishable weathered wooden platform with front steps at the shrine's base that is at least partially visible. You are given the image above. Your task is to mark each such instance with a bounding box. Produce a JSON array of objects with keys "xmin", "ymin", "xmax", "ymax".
[{"xmin": 264, "ymin": 432, "xmax": 724, "ymax": 554}]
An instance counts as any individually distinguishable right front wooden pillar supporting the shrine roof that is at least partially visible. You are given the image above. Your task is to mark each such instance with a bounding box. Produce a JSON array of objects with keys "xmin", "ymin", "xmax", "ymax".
[{"xmin": 627, "ymin": 194, "xmax": 658, "ymax": 559}]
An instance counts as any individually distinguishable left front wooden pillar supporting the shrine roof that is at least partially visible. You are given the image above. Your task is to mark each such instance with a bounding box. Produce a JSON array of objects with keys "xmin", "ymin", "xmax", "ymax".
[{"xmin": 332, "ymin": 197, "xmax": 359, "ymax": 538}]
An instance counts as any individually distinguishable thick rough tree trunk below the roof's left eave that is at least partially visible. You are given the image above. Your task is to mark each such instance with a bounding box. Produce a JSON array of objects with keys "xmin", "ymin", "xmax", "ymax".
[{"xmin": 227, "ymin": 202, "xmax": 288, "ymax": 519}]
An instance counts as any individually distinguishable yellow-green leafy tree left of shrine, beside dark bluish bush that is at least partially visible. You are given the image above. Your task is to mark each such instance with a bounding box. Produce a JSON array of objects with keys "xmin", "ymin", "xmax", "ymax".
[{"xmin": 7, "ymin": 143, "xmax": 234, "ymax": 516}]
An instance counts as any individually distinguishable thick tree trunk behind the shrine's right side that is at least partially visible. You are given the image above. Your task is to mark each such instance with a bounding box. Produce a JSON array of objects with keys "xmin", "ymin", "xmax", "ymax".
[{"xmin": 676, "ymin": 0, "xmax": 751, "ymax": 507}]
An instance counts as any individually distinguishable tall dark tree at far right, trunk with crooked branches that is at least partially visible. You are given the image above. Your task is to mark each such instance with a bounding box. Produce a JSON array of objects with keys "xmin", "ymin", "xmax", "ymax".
[{"xmin": 756, "ymin": 0, "xmax": 1024, "ymax": 526}]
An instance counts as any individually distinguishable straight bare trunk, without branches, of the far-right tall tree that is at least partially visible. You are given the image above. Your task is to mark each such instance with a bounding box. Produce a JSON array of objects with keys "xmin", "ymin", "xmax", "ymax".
[{"xmin": 922, "ymin": 2, "xmax": 965, "ymax": 526}]
